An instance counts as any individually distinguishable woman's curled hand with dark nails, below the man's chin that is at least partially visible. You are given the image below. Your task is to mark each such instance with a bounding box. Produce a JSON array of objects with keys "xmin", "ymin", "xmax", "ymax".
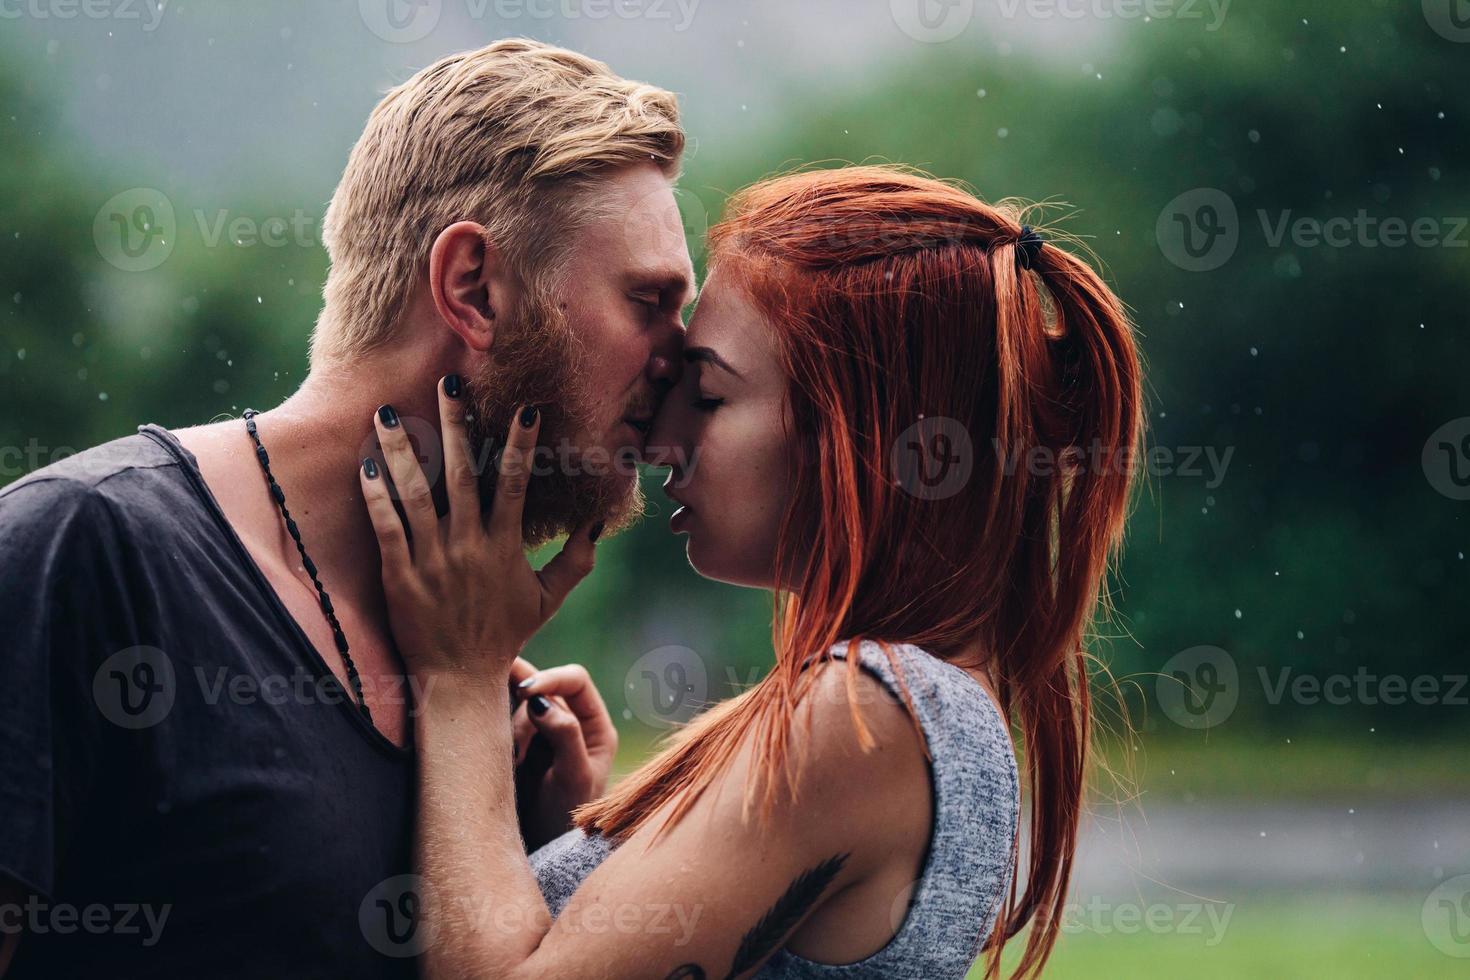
[{"xmin": 510, "ymin": 658, "xmax": 617, "ymax": 849}]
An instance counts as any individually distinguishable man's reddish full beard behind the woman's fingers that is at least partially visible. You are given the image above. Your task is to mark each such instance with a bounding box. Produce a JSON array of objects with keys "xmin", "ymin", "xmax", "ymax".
[{"xmin": 466, "ymin": 290, "xmax": 644, "ymax": 548}]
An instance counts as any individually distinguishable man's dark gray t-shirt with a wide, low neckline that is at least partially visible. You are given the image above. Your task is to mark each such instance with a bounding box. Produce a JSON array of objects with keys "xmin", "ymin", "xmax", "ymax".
[{"xmin": 0, "ymin": 426, "xmax": 422, "ymax": 980}]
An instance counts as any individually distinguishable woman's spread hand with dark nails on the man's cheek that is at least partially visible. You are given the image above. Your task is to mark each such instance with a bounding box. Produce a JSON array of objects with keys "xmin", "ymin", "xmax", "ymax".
[{"xmin": 359, "ymin": 382, "xmax": 601, "ymax": 685}]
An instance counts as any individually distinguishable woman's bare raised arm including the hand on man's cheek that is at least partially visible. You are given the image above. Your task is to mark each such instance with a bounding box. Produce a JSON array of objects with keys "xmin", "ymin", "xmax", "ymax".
[{"xmin": 363, "ymin": 389, "xmax": 926, "ymax": 980}]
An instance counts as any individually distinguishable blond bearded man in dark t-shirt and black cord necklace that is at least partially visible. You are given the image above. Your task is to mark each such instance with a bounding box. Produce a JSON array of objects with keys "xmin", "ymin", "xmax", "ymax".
[{"xmin": 0, "ymin": 40, "xmax": 692, "ymax": 979}]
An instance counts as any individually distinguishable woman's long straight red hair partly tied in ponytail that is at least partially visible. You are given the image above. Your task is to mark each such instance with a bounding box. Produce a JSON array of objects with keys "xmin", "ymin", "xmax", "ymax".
[{"xmin": 576, "ymin": 166, "xmax": 1144, "ymax": 977}]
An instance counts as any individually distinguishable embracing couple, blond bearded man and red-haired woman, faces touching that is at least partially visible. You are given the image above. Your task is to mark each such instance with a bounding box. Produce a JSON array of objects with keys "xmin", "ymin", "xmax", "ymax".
[{"xmin": 0, "ymin": 40, "xmax": 1142, "ymax": 980}]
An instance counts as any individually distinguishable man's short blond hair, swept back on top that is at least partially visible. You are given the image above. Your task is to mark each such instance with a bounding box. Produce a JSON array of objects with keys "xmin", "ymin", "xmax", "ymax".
[{"xmin": 312, "ymin": 38, "xmax": 684, "ymax": 363}]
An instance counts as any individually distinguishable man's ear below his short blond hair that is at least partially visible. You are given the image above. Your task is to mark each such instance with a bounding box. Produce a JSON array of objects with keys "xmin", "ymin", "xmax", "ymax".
[{"xmin": 429, "ymin": 222, "xmax": 522, "ymax": 353}]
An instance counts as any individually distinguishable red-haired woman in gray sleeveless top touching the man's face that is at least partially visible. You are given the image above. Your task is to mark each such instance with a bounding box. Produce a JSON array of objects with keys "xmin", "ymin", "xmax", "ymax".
[{"xmin": 363, "ymin": 167, "xmax": 1142, "ymax": 977}]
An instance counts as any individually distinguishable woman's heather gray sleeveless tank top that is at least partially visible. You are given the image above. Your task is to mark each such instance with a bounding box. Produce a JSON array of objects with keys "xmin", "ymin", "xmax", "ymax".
[{"xmin": 531, "ymin": 642, "xmax": 1020, "ymax": 980}]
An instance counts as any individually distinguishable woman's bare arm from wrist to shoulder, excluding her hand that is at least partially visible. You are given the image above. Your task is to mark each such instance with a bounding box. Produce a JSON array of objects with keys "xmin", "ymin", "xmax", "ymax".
[{"xmin": 416, "ymin": 667, "xmax": 905, "ymax": 980}]
